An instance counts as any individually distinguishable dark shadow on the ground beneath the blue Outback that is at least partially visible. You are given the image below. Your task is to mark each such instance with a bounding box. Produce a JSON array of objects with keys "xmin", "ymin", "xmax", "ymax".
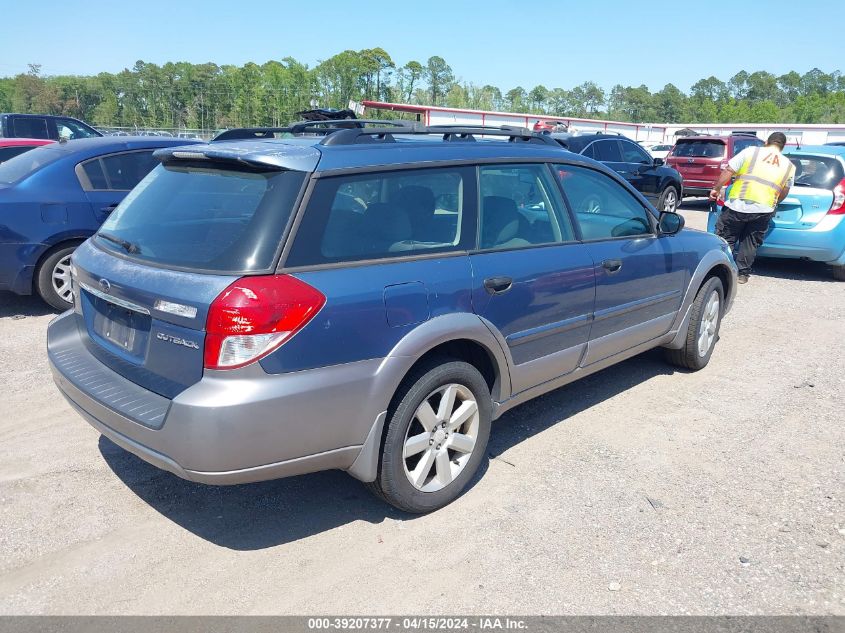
[{"xmin": 99, "ymin": 350, "xmax": 675, "ymax": 550}]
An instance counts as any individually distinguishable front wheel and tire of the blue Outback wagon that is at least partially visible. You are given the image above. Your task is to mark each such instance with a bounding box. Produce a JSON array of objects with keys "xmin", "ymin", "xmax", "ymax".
[{"xmin": 666, "ymin": 277, "xmax": 725, "ymax": 371}]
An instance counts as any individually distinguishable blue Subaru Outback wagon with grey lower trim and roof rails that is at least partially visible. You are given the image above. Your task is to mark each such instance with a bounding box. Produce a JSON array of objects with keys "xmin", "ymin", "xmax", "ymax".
[{"xmin": 48, "ymin": 122, "xmax": 736, "ymax": 512}]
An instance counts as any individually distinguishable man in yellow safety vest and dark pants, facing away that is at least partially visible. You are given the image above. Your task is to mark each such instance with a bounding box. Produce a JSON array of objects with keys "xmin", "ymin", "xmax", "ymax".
[{"xmin": 710, "ymin": 132, "xmax": 795, "ymax": 284}]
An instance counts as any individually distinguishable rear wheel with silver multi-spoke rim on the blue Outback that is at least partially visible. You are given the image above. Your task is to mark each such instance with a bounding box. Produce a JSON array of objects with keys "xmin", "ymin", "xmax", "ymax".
[{"xmin": 367, "ymin": 358, "xmax": 492, "ymax": 514}]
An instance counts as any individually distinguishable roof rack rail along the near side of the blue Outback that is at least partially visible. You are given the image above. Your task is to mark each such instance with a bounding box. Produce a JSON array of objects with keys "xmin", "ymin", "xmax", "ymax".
[{"xmin": 320, "ymin": 125, "xmax": 560, "ymax": 147}]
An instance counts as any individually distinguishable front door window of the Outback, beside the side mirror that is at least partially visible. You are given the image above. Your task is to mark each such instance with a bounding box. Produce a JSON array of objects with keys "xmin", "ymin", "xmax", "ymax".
[{"xmin": 556, "ymin": 165, "xmax": 652, "ymax": 240}]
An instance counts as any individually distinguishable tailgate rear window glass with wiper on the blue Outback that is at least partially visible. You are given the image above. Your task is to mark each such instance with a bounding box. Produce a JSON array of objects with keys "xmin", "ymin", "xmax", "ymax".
[{"xmin": 97, "ymin": 164, "xmax": 305, "ymax": 273}]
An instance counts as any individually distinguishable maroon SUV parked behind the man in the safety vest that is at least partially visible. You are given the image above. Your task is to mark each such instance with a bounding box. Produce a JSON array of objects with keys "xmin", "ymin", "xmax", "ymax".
[{"xmin": 666, "ymin": 134, "xmax": 763, "ymax": 197}]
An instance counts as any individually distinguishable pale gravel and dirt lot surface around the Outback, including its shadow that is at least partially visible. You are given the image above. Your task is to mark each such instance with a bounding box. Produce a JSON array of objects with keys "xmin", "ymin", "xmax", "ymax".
[{"xmin": 0, "ymin": 205, "xmax": 845, "ymax": 614}]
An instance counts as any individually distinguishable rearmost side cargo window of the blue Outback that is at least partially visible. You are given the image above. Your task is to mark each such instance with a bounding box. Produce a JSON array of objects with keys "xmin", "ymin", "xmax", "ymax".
[{"xmin": 286, "ymin": 167, "xmax": 475, "ymax": 266}]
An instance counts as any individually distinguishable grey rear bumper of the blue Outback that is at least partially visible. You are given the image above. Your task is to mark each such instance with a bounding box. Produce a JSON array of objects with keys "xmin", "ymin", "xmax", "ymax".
[{"xmin": 47, "ymin": 312, "xmax": 381, "ymax": 485}]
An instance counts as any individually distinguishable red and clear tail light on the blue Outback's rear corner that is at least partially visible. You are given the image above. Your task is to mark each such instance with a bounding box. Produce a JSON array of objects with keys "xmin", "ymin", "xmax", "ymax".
[{"xmin": 204, "ymin": 275, "xmax": 326, "ymax": 369}]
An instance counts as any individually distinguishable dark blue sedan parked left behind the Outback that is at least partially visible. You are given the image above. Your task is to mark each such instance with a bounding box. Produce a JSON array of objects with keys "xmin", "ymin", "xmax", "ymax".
[{"xmin": 0, "ymin": 136, "xmax": 199, "ymax": 310}]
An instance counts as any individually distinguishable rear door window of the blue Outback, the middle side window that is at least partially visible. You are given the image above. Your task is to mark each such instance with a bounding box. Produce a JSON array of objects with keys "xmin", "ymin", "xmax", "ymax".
[{"xmin": 479, "ymin": 165, "xmax": 574, "ymax": 249}]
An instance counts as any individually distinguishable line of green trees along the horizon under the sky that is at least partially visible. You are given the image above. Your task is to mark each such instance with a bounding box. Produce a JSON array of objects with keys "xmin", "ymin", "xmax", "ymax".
[{"xmin": 0, "ymin": 48, "xmax": 845, "ymax": 129}]
